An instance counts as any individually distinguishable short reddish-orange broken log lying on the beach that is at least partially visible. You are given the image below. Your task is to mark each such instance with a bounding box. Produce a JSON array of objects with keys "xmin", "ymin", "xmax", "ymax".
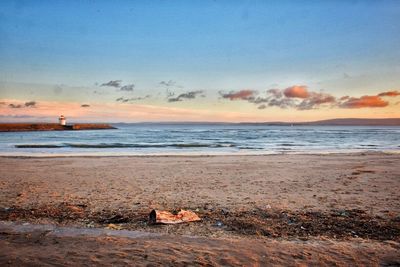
[{"xmin": 149, "ymin": 210, "xmax": 201, "ymax": 224}]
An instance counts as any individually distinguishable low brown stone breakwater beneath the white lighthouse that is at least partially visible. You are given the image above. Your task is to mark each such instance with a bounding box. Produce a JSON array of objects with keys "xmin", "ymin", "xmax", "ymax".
[{"xmin": 0, "ymin": 123, "xmax": 116, "ymax": 132}]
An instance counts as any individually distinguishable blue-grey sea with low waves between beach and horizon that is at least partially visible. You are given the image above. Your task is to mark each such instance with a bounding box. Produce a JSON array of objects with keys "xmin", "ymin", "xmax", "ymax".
[{"xmin": 0, "ymin": 124, "xmax": 400, "ymax": 156}]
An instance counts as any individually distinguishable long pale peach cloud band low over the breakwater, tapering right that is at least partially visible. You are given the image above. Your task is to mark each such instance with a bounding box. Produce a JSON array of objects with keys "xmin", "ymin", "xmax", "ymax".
[{"xmin": 0, "ymin": 99, "xmax": 276, "ymax": 122}]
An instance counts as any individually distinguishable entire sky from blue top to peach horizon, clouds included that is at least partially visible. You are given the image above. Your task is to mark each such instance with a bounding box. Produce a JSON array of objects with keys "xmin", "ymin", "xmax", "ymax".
[{"xmin": 0, "ymin": 0, "xmax": 400, "ymax": 122}]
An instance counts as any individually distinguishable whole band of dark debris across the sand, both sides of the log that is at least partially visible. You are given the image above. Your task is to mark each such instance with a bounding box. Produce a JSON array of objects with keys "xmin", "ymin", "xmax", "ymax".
[{"xmin": 0, "ymin": 203, "xmax": 400, "ymax": 241}]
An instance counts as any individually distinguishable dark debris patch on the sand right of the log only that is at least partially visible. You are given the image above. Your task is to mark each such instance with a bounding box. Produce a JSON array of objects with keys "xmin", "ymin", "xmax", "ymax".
[{"xmin": 209, "ymin": 209, "xmax": 400, "ymax": 240}]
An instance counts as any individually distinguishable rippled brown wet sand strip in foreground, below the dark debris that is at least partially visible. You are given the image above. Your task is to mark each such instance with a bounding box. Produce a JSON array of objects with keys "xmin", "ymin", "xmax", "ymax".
[{"xmin": 0, "ymin": 222, "xmax": 400, "ymax": 266}]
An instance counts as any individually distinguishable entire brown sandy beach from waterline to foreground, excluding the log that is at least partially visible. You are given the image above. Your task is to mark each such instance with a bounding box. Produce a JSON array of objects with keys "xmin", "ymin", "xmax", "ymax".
[{"xmin": 0, "ymin": 153, "xmax": 400, "ymax": 265}]
